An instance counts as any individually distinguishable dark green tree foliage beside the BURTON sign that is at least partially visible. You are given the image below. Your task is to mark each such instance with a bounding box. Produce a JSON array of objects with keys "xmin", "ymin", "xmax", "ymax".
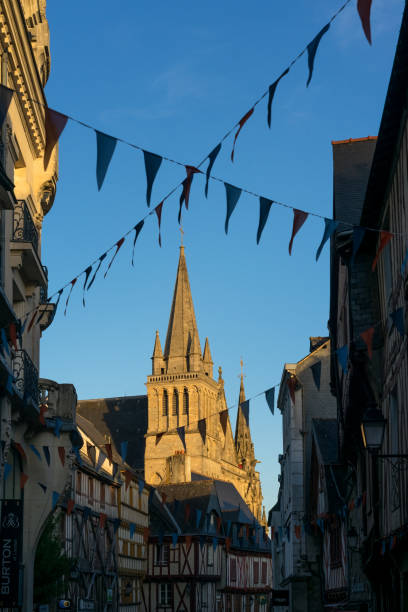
[{"xmin": 34, "ymin": 517, "xmax": 75, "ymax": 604}]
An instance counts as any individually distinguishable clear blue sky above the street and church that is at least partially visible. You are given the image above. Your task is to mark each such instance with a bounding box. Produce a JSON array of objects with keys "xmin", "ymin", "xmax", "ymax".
[{"xmin": 40, "ymin": 0, "xmax": 404, "ymax": 510}]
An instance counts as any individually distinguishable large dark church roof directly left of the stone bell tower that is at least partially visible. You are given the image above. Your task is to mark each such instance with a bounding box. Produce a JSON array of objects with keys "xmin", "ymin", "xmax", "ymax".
[{"xmin": 77, "ymin": 395, "xmax": 147, "ymax": 474}]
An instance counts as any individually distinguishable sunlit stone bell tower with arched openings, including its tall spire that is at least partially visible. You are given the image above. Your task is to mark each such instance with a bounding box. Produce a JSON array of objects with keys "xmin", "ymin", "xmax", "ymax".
[{"xmin": 145, "ymin": 246, "xmax": 230, "ymax": 485}]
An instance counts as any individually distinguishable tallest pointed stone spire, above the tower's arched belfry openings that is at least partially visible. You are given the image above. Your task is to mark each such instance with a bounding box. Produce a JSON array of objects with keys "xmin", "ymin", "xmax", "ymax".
[{"xmin": 164, "ymin": 246, "xmax": 201, "ymax": 373}]
